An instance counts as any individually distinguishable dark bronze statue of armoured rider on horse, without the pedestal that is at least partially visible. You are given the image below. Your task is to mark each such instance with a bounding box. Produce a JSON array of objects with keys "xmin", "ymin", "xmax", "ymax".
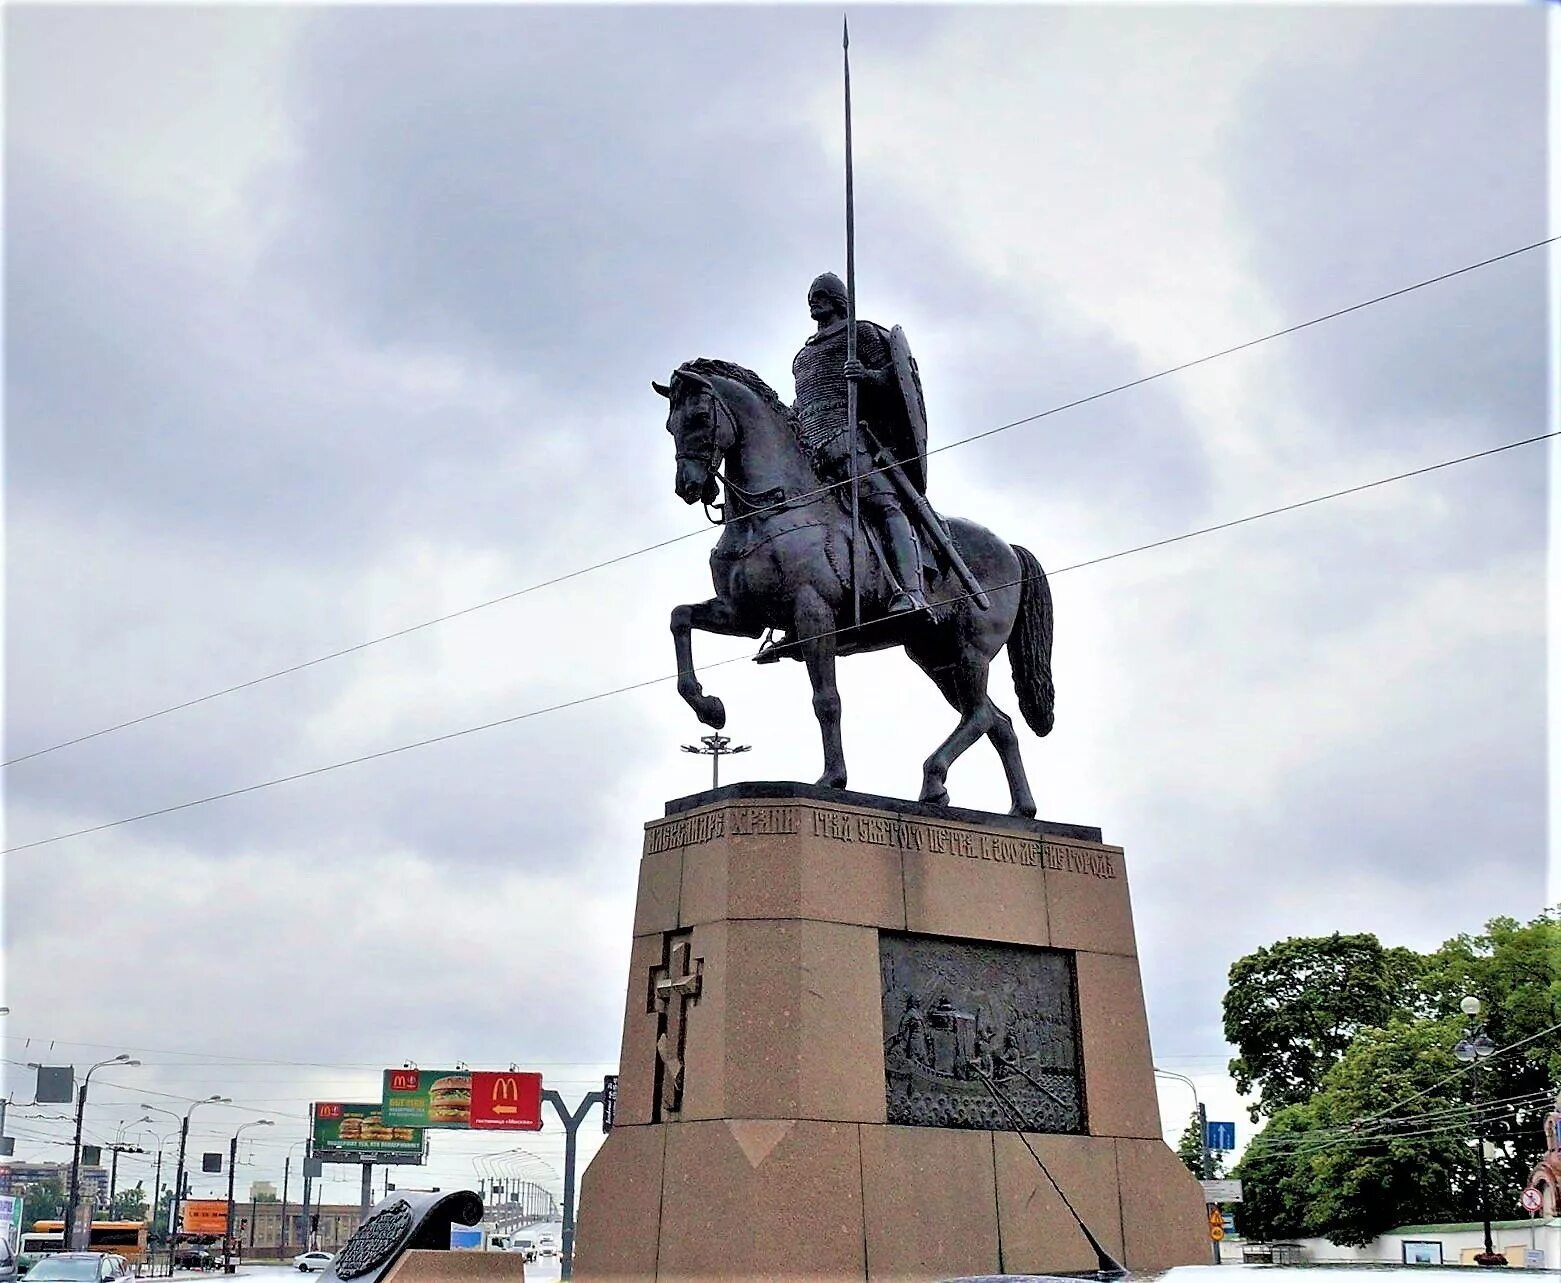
[{"xmin": 652, "ymin": 273, "xmax": 1054, "ymax": 816}]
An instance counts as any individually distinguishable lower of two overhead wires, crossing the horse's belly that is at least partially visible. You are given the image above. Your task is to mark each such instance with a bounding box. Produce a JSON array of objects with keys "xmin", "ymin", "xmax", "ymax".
[{"xmin": 0, "ymin": 431, "xmax": 1561, "ymax": 855}]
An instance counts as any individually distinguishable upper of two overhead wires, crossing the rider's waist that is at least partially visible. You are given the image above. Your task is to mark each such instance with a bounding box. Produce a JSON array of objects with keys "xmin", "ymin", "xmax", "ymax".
[{"xmin": 9, "ymin": 236, "xmax": 1561, "ymax": 768}]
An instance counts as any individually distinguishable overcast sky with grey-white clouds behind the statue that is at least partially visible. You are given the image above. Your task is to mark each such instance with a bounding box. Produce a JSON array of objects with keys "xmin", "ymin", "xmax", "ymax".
[{"xmin": 5, "ymin": 6, "xmax": 1549, "ymax": 1200}]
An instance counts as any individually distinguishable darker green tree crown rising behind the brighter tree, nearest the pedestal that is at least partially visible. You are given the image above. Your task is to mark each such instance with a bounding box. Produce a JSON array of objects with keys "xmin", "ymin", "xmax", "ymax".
[{"xmin": 1224, "ymin": 932, "xmax": 1425, "ymax": 1122}]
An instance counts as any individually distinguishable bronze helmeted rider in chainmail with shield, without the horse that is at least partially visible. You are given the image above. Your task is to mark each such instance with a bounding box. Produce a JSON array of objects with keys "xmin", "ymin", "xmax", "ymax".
[{"xmin": 791, "ymin": 272, "xmax": 927, "ymax": 615}]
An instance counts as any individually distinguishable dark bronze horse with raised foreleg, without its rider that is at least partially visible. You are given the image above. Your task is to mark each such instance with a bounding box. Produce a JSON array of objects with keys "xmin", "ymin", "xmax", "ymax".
[{"xmin": 652, "ymin": 359, "xmax": 1054, "ymax": 816}]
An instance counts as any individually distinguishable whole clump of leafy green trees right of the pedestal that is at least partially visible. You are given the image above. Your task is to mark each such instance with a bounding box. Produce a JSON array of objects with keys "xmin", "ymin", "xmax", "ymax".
[{"xmin": 1225, "ymin": 913, "xmax": 1561, "ymax": 1244}]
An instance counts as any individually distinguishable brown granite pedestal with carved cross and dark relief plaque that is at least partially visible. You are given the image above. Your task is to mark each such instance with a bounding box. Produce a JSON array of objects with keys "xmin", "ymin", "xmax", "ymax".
[{"xmin": 574, "ymin": 785, "xmax": 1208, "ymax": 1280}]
